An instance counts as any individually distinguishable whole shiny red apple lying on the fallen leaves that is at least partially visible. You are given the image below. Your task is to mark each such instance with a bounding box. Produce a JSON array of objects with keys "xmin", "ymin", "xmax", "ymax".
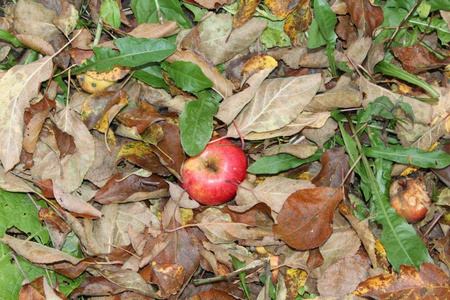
[{"xmin": 181, "ymin": 139, "xmax": 248, "ymax": 205}]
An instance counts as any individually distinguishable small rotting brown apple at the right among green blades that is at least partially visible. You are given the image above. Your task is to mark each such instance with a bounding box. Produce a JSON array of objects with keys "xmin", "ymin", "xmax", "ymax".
[{"xmin": 389, "ymin": 178, "xmax": 431, "ymax": 223}]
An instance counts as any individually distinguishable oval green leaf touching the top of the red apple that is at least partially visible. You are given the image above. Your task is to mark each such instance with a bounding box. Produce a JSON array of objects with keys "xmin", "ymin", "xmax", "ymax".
[{"xmin": 179, "ymin": 91, "xmax": 219, "ymax": 156}]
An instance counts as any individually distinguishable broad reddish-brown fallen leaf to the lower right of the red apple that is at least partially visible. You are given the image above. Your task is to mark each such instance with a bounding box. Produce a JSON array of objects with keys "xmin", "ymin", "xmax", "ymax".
[{"xmin": 273, "ymin": 187, "xmax": 343, "ymax": 250}]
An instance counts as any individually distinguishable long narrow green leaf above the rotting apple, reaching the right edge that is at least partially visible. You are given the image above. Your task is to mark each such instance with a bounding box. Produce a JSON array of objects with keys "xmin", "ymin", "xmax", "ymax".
[{"xmin": 364, "ymin": 145, "xmax": 450, "ymax": 169}]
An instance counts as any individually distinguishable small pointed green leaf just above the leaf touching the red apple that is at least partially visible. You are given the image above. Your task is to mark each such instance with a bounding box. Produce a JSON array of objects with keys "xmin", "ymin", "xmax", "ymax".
[{"xmin": 162, "ymin": 61, "xmax": 212, "ymax": 93}]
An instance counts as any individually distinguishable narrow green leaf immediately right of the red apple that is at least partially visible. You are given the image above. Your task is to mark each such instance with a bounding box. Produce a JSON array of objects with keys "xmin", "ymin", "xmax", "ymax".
[{"xmin": 247, "ymin": 150, "xmax": 322, "ymax": 174}]
